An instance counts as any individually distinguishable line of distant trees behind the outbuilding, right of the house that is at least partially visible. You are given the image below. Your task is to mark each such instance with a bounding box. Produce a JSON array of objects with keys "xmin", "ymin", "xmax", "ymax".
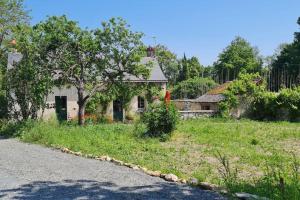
[{"xmin": 156, "ymin": 17, "xmax": 300, "ymax": 98}]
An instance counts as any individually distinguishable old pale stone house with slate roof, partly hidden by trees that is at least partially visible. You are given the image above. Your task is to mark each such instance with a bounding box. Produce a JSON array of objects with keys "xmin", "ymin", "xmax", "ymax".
[{"xmin": 8, "ymin": 47, "xmax": 168, "ymax": 121}]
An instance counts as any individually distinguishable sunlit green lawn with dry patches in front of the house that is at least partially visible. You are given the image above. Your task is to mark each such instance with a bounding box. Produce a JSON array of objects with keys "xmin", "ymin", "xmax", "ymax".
[{"xmin": 6, "ymin": 119, "xmax": 300, "ymax": 199}]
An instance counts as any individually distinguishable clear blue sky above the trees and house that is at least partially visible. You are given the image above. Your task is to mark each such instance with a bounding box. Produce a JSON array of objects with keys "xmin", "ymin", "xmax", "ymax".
[{"xmin": 25, "ymin": 0, "xmax": 300, "ymax": 65}]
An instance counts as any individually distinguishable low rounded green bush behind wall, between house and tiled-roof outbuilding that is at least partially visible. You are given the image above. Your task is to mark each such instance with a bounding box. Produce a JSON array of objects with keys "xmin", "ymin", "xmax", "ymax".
[{"xmin": 172, "ymin": 77, "xmax": 217, "ymax": 99}]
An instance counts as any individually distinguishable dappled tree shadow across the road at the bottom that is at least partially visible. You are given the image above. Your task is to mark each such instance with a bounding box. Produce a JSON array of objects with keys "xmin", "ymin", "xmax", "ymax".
[{"xmin": 0, "ymin": 180, "xmax": 224, "ymax": 200}]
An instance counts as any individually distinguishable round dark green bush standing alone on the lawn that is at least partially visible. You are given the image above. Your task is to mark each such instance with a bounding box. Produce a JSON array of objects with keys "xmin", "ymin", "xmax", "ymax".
[{"xmin": 142, "ymin": 103, "xmax": 179, "ymax": 139}]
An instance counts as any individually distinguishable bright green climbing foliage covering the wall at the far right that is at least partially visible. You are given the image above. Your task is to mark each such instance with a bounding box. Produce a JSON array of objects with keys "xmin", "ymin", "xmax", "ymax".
[{"xmin": 219, "ymin": 74, "xmax": 300, "ymax": 121}]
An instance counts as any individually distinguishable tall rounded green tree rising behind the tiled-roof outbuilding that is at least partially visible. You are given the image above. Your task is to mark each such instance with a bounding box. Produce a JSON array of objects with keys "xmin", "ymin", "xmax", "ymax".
[{"xmin": 214, "ymin": 37, "xmax": 262, "ymax": 83}]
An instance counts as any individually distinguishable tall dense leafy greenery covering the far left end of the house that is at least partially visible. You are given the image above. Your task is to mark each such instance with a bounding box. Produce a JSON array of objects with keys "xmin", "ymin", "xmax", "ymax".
[{"xmin": 6, "ymin": 25, "xmax": 54, "ymax": 120}]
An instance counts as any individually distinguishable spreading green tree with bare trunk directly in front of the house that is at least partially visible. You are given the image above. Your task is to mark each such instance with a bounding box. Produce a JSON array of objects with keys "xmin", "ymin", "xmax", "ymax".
[{"xmin": 38, "ymin": 16, "xmax": 149, "ymax": 125}]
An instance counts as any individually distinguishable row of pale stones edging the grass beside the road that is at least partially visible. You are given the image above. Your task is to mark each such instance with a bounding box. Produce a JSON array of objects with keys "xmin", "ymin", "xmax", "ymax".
[{"xmin": 52, "ymin": 146, "xmax": 232, "ymax": 195}]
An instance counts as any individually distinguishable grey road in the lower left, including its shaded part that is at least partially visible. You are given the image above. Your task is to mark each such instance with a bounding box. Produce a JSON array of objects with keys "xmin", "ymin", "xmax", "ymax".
[{"xmin": 0, "ymin": 139, "xmax": 223, "ymax": 200}]
